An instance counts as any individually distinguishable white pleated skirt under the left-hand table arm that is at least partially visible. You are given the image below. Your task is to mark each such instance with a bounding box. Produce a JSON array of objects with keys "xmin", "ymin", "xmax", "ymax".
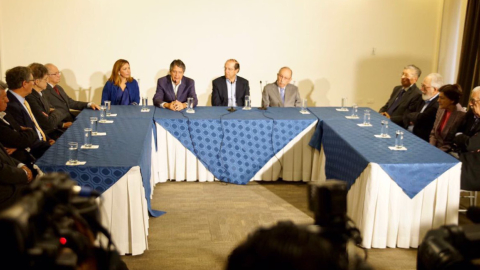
[{"xmin": 95, "ymin": 129, "xmax": 158, "ymax": 255}]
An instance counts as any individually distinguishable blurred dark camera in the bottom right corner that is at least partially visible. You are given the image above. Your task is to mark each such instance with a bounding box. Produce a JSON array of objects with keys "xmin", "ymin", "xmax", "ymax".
[{"xmin": 417, "ymin": 207, "xmax": 480, "ymax": 270}]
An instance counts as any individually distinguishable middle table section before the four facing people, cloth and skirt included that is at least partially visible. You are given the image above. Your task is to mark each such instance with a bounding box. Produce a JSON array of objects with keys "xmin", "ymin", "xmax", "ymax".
[{"xmin": 154, "ymin": 107, "xmax": 318, "ymax": 184}]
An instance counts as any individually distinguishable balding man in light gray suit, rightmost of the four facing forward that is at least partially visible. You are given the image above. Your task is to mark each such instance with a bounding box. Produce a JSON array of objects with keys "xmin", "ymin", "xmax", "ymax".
[{"xmin": 262, "ymin": 67, "xmax": 302, "ymax": 108}]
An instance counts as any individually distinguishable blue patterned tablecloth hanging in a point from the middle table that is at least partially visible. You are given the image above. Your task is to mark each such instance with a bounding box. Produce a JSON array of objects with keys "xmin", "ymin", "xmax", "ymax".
[{"xmin": 154, "ymin": 107, "xmax": 317, "ymax": 184}]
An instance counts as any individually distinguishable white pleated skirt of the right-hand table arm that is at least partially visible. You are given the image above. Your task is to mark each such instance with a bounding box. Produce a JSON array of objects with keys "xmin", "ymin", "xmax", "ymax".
[{"xmin": 312, "ymin": 148, "xmax": 461, "ymax": 248}]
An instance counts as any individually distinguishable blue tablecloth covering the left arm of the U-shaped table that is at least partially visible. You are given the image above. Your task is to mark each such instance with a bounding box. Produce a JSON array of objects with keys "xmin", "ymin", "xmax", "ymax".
[{"xmin": 37, "ymin": 106, "xmax": 163, "ymax": 216}]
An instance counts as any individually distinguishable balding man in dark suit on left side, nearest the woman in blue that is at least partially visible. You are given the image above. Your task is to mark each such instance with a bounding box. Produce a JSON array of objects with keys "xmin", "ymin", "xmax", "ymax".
[{"xmin": 43, "ymin": 64, "xmax": 100, "ymax": 123}]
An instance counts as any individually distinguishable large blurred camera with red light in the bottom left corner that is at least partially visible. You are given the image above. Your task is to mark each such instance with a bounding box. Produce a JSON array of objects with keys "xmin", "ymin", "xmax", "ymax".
[{"xmin": 0, "ymin": 173, "xmax": 126, "ymax": 269}]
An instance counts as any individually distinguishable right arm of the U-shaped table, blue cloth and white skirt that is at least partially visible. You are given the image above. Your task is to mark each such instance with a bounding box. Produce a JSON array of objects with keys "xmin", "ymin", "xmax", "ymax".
[{"xmin": 309, "ymin": 108, "xmax": 461, "ymax": 248}]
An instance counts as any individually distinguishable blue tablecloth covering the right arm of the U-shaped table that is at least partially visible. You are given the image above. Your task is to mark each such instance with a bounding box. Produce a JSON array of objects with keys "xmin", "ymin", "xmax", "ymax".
[{"xmin": 309, "ymin": 107, "xmax": 459, "ymax": 198}]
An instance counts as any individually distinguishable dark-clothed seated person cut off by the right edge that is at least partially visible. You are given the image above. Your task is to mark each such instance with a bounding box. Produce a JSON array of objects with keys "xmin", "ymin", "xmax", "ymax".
[{"xmin": 453, "ymin": 86, "xmax": 480, "ymax": 191}]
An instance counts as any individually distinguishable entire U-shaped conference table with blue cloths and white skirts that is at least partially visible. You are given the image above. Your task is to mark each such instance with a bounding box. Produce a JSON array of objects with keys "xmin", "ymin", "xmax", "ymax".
[{"xmin": 38, "ymin": 106, "xmax": 460, "ymax": 255}]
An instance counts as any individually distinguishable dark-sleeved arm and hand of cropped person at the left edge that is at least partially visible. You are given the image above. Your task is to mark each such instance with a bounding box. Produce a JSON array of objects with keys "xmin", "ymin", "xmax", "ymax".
[{"xmin": 0, "ymin": 141, "xmax": 33, "ymax": 211}]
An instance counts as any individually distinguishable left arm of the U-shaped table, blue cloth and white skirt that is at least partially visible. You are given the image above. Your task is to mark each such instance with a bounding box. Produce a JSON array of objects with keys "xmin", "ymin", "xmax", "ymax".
[{"xmin": 37, "ymin": 106, "xmax": 162, "ymax": 255}]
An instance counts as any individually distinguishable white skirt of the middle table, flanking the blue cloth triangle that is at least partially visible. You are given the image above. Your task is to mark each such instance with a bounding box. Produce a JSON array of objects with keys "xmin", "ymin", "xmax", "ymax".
[{"xmin": 152, "ymin": 121, "xmax": 317, "ymax": 183}]
